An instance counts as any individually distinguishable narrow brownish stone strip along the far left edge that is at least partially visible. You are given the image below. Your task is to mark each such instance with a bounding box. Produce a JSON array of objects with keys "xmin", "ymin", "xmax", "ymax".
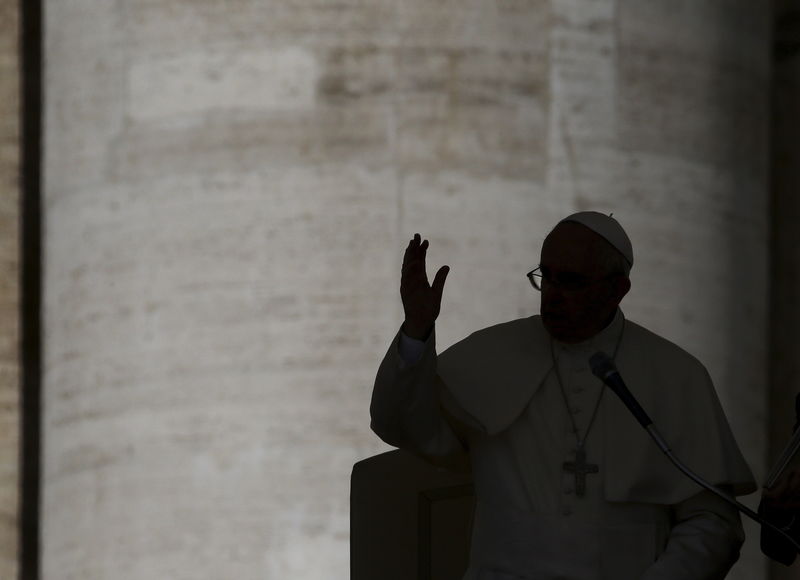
[{"xmin": 0, "ymin": 0, "xmax": 20, "ymax": 578}]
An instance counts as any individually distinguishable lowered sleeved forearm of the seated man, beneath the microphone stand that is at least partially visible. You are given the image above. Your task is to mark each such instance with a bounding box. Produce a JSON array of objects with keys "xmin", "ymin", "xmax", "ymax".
[{"xmin": 641, "ymin": 486, "xmax": 744, "ymax": 580}]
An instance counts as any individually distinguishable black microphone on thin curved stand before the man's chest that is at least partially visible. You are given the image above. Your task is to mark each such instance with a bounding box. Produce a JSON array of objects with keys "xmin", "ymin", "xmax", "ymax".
[{"xmin": 589, "ymin": 351, "xmax": 800, "ymax": 552}]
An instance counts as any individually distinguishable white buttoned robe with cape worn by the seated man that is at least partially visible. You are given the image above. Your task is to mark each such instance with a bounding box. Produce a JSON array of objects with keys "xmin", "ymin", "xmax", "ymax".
[{"xmin": 370, "ymin": 310, "xmax": 756, "ymax": 580}]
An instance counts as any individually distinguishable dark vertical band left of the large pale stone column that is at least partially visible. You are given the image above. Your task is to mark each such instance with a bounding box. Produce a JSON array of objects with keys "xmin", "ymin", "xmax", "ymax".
[{"xmin": 19, "ymin": 0, "xmax": 42, "ymax": 580}]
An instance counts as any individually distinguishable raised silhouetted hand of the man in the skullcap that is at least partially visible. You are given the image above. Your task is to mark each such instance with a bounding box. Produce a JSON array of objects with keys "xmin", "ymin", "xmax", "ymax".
[{"xmin": 400, "ymin": 234, "xmax": 450, "ymax": 340}]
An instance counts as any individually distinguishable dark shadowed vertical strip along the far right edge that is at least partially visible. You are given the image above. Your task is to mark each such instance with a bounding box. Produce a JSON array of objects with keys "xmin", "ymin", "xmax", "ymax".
[{"xmin": 768, "ymin": 0, "xmax": 800, "ymax": 580}]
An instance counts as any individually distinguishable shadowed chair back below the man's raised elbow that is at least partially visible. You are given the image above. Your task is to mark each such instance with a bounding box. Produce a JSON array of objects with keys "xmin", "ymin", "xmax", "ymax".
[{"xmin": 350, "ymin": 449, "xmax": 475, "ymax": 580}]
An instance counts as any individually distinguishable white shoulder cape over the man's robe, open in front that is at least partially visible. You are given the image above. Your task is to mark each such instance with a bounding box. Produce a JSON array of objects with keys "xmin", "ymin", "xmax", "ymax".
[{"xmin": 437, "ymin": 315, "xmax": 757, "ymax": 504}]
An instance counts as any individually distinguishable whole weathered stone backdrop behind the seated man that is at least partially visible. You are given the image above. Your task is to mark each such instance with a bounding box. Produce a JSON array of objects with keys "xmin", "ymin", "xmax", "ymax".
[{"xmin": 0, "ymin": 0, "xmax": 800, "ymax": 580}]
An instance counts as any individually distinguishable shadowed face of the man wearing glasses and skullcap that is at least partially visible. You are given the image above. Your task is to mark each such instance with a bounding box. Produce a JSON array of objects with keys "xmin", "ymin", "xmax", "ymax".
[{"xmin": 540, "ymin": 222, "xmax": 630, "ymax": 343}]
